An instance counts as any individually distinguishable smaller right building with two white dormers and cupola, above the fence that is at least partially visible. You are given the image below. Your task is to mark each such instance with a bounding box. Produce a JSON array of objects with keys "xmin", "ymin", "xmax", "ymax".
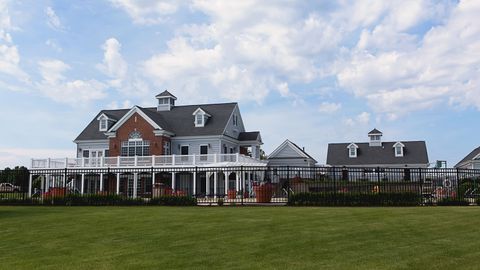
[{"xmin": 327, "ymin": 129, "xmax": 429, "ymax": 168}]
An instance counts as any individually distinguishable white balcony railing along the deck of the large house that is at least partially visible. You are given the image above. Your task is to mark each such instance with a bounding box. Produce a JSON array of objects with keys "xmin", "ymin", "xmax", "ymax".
[{"xmin": 31, "ymin": 154, "xmax": 265, "ymax": 169}]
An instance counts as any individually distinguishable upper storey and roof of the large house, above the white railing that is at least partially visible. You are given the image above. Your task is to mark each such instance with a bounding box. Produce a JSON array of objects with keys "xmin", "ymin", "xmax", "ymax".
[{"xmin": 74, "ymin": 91, "xmax": 262, "ymax": 161}]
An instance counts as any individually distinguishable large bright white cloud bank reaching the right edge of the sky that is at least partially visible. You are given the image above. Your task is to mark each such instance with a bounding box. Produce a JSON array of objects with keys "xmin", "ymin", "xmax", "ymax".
[{"xmin": 338, "ymin": 1, "xmax": 480, "ymax": 119}]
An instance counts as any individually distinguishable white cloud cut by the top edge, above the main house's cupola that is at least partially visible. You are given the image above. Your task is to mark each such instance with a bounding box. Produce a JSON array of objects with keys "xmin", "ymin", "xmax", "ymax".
[{"xmin": 110, "ymin": 0, "xmax": 180, "ymax": 25}]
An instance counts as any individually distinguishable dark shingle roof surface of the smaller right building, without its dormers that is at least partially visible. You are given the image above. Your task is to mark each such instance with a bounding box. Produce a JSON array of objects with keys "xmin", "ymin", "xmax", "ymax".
[{"xmin": 327, "ymin": 141, "xmax": 428, "ymax": 166}]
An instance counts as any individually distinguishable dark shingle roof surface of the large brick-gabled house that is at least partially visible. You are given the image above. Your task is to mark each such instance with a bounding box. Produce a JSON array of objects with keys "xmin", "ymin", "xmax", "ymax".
[{"xmin": 75, "ymin": 103, "xmax": 237, "ymax": 141}]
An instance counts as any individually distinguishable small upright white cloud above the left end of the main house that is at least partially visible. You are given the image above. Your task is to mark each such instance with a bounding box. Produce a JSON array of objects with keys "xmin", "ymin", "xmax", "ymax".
[{"xmin": 97, "ymin": 38, "xmax": 128, "ymax": 87}]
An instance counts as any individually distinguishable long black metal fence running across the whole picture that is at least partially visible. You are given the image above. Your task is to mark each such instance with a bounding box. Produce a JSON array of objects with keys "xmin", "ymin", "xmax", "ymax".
[{"xmin": 0, "ymin": 166, "xmax": 480, "ymax": 205}]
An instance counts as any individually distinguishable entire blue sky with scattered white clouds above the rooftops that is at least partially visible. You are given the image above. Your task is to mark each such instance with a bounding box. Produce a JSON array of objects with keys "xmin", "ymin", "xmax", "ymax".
[{"xmin": 0, "ymin": 0, "xmax": 480, "ymax": 167}]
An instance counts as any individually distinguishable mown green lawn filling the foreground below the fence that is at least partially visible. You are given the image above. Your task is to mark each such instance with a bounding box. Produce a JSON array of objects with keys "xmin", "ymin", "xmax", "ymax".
[{"xmin": 0, "ymin": 207, "xmax": 480, "ymax": 269}]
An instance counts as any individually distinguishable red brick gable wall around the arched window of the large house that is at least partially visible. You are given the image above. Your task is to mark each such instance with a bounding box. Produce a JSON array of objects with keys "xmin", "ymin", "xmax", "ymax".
[{"xmin": 109, "ymin": 113, "xmax": 170, "ymax": 157}]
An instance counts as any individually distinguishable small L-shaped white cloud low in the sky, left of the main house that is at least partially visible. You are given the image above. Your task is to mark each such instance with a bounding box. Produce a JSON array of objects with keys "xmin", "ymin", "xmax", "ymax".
[{"xmin": 37, "ymin": 60, "xmax": 107, "ymax": 106}]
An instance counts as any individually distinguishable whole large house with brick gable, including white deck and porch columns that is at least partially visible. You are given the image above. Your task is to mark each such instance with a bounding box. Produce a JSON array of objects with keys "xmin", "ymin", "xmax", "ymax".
[{"xmin": 32, "ymin": 91, "xmax": 266, "ymax": 198}]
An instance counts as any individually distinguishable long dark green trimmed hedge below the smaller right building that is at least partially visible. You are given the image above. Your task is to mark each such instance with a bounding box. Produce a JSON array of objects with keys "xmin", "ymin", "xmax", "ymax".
[{"xmin": 288, "ymin": 192, "xmax": 422, "ymax": 206}]
